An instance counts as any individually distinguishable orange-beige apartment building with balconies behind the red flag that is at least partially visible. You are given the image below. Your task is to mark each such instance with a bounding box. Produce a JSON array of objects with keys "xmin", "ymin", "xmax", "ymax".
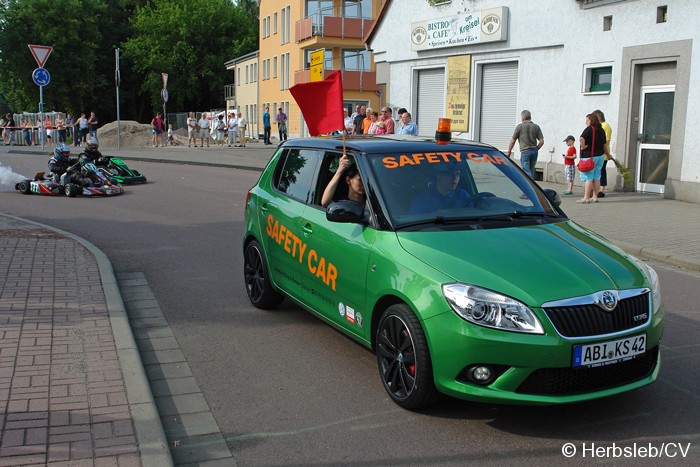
[{"xmin": 253, "ymin": 0, "xmax": 383, "ymax": 138}]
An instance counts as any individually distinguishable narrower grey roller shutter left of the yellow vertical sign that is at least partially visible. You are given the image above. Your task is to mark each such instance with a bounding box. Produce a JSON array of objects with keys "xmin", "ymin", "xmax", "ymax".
[{"xmin": 413, "ymin": 68, "xmax": 445, "ymax": 138}]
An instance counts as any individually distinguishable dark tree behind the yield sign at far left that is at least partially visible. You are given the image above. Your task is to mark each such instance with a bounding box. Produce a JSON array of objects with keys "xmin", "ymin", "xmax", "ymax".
[{"xmin": 0, "ymin": 0, "xmax": 105, "ymax": 117}]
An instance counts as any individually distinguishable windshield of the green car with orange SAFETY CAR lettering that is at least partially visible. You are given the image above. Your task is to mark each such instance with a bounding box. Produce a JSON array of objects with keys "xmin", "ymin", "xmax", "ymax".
[{"xmin": 369, "ymin": 148, "xmax": 562, "ymax": 228}]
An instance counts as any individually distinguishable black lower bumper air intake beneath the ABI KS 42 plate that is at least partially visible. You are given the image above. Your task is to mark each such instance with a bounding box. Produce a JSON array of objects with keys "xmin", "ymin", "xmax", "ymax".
[{"xmin": 516, "ymin": 346, "xmax": 659, "ymax": 396}]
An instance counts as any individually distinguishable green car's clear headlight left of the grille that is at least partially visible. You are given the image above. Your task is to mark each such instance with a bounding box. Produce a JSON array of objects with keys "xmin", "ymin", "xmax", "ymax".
[{"xmin": 442, "ymin": 284, "xmax": 544, "ymax": 334}]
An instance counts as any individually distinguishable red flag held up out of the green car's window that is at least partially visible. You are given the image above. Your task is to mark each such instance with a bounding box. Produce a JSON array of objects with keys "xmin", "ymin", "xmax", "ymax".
[{"xmin": 289, "ymin": 70, "xmax": 345, "ymax": 136}]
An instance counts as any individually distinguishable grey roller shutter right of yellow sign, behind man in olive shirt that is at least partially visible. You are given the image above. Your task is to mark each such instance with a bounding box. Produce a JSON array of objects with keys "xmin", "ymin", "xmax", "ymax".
[{"xmin": 479, "ymin": 62, "xmax": 519, "ymax": 151}]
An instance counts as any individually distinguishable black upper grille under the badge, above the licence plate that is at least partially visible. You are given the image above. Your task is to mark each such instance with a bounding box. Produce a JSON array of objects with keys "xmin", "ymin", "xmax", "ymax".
[{"xmin": 543, "ymin": 291, "xmax": 651, "ymax": 338}]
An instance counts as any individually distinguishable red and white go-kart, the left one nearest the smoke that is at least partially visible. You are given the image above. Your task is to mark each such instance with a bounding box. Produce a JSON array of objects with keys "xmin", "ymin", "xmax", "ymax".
[{"xmin": 15, "ymin": 162, "xmax": 124, "ymax": 198}]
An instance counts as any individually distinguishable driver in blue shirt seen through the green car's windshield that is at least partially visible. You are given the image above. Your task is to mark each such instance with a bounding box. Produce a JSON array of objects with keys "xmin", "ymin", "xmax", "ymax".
[{"xmin": 411, "ymin": 162, "xmax": 471, "ymax": 214}]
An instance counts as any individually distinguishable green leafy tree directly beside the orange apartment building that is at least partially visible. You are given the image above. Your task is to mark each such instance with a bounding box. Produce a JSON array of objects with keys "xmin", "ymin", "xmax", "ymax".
[{"xmin": 124, "ymin": 0, "xmax": 258, "ymax": 119}]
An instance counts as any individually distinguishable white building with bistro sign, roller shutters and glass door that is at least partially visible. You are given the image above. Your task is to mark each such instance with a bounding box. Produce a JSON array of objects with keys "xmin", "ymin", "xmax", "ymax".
[{"xmin": 365, "ymin": 0, "xmax": 700, "ymax": 203}]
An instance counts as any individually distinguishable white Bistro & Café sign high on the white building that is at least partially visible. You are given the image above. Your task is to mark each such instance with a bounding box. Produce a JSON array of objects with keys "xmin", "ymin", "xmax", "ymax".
[{"xmin": 411, "ymin": 7, "xmax": 508, "ymax": 50}]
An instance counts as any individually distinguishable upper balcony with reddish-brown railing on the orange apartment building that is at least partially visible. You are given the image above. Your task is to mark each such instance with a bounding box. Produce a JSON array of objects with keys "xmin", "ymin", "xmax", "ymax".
[{"xmin": 294, "ymin": 14, "xmax": 374, "ymax": 43}]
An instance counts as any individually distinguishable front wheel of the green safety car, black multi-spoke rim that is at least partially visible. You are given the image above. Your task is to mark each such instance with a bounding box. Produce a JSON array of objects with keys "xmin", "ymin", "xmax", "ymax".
[{"xmin": 376, "ymin": 303, "xmax": 439, "ymax": 410}]
